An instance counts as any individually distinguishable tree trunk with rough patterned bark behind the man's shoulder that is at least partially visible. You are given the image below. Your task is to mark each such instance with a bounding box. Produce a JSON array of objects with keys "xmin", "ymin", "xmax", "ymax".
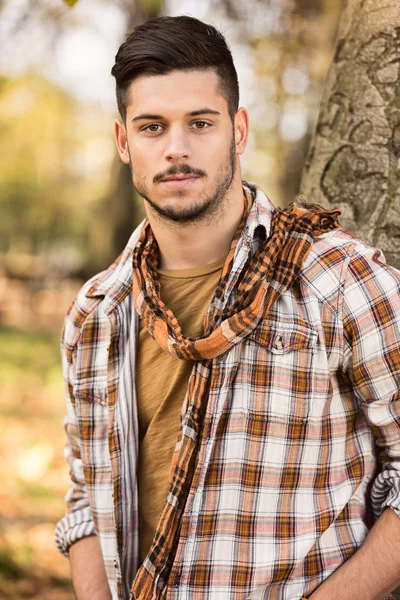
[{"xmin": 300, "ymin": 0, "xmax": 400, "ymax": 267}]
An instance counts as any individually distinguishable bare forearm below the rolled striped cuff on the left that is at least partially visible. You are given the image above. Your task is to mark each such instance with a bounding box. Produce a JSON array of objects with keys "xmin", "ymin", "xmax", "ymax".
[{"xmin": 69, "ymin": 535, "xmax": 111, "ymax": 600}]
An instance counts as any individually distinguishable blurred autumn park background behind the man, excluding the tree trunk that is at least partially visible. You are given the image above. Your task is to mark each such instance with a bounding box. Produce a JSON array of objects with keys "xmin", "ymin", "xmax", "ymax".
[{"xmin": 0, "ymin": 0, "xmax": 341, "ymax": 600}]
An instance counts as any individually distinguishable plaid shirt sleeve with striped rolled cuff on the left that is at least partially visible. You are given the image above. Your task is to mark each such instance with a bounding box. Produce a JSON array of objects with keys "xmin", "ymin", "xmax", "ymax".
[{"xmin": 54, "ymin": 317, "xmax": 95, "ymax": 556}]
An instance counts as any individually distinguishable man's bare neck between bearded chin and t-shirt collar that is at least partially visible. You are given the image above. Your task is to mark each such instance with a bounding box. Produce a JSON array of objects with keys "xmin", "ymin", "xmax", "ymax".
[{"xmin": 146, "ymin": 181, "xmax": 244, "ymax": 270}]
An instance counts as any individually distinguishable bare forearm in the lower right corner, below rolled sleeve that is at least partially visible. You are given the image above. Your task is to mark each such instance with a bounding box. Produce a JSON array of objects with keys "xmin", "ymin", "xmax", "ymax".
[{"xmin": 309, "ymin": 508, "xmax": 400, "ymax": 600}]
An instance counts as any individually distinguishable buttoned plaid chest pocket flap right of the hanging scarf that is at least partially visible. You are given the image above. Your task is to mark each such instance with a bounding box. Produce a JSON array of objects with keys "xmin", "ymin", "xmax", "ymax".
[{"xmin": 250, "ymin": 320, "xmax": 317, "ymax": 354}]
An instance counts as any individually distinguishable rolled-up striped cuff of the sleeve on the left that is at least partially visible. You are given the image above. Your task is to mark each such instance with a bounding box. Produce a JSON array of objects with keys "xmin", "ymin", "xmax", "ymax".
[{"xmin": 54, "ymin": 506, "xmax": 96, "ymax": 557}]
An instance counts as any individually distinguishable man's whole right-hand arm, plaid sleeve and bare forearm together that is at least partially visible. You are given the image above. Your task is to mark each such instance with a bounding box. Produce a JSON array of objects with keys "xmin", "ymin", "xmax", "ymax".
[{"xmin": 310, "ymin": 243, "xmax": 400, "ymax": 600}]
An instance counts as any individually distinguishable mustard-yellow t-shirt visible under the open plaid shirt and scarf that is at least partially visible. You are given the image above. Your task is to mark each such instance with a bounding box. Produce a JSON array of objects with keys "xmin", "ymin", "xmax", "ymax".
[{"xmin": 136, "ymin": 260, "xmax": 225, "ymax": 561}]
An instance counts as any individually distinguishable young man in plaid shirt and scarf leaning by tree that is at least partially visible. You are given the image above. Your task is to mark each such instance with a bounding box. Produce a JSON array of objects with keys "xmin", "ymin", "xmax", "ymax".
[{"xmin": 56, "ymin": 12, "xmax": 400, "ymax": 600}]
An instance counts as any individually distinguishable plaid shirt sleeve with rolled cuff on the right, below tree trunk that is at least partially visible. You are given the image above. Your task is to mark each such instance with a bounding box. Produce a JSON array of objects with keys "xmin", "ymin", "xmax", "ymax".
[{"xmin": 343, "ymin": 244, "xmax": 400, "ymax": 517}]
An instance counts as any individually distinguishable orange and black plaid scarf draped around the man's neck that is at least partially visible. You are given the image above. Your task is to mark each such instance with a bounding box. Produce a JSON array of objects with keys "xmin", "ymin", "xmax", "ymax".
[{"xmin": 131, "ymin": 189, "xmax": 340, "ymax": 600}]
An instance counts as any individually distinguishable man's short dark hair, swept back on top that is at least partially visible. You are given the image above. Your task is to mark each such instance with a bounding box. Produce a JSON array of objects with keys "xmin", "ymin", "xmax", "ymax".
[{"xmin": 111, "ymin": 16, "xmax": 239, "ymax": 122}]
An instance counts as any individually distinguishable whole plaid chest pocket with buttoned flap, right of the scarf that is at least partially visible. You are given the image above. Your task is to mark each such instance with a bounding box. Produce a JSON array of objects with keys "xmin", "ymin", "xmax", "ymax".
[{"xmin": 234, "ymin": 319, "xmax": 318, "ymax": 424}]
